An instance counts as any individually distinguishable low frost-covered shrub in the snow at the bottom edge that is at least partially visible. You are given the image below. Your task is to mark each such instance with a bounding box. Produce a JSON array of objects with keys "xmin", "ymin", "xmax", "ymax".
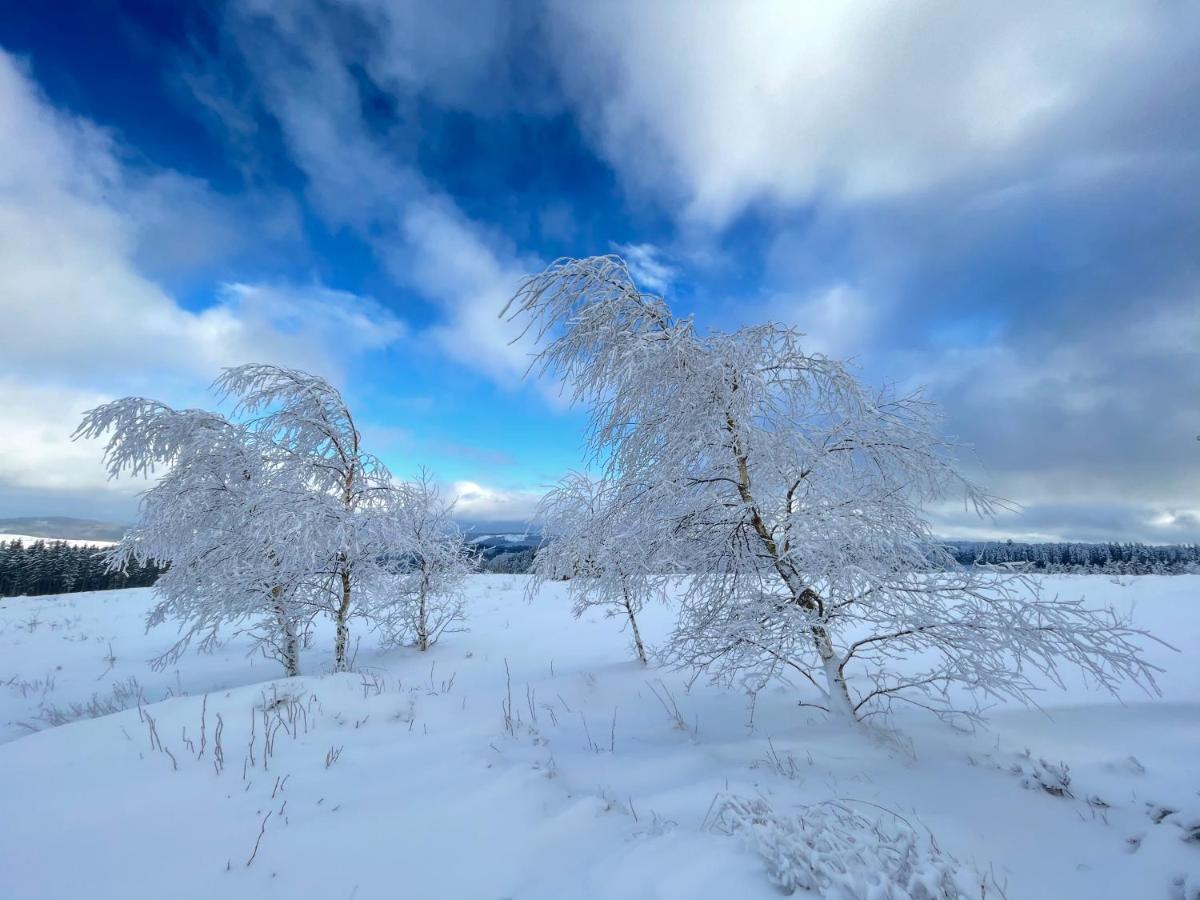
[{"xmin": 712, "ymin": 794, "xmax": 979, "ymax": 900}]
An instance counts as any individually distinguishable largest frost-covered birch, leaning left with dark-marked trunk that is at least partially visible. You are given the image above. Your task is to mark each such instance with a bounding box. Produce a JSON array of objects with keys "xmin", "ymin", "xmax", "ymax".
[{"xmin": 508, "ymin": 257, "xmax": 1154, "ymax": 719}]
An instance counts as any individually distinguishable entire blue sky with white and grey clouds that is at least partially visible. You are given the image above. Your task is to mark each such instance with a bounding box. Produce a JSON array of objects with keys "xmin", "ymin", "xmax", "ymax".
[{"xmin": 0, "ymin": 0, "xmax": 1200, "ymax": 541}]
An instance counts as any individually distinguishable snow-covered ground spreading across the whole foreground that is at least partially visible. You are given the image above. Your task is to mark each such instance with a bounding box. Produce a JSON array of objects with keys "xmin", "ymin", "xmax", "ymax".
[{"xmin": 0, "ymin": 576, "xmax": 1200, "ymax": 900}]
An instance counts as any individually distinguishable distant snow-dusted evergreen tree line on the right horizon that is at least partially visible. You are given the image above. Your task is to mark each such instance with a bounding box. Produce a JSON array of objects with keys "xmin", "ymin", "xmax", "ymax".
[{"xmin": 949, "ymin": 540, "xmax": 1200, "ymax": 575}]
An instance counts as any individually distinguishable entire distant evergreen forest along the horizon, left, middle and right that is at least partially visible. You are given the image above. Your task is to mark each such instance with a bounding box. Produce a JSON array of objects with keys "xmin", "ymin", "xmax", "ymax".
[{"xmin": 0, "ymin": 540, "xmax": 1200, "ymax": 596}]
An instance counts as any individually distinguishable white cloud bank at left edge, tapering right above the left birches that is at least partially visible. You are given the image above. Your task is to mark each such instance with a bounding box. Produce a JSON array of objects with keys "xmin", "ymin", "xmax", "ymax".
[{"xmin": 0, "ymin": 52, "xmax": 402, "ymax": 384}]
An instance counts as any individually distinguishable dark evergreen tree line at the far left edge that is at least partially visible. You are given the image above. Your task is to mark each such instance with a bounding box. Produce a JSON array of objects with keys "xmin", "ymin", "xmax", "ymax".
[{"xmin": 0, "ymin": 539, "xmax": 162, "ymax": 596}]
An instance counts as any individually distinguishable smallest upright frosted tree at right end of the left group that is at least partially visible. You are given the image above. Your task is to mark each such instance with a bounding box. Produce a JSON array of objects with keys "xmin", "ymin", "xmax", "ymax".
[{"xmin": 372, "ymin": 469, "xmax": 474, "ymax": 650}]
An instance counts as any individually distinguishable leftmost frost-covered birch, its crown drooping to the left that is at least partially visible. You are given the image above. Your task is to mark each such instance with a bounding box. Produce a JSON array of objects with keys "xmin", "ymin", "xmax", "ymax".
[{"xmin": 76, "ymin": 397, "xmax": 311, "ymax": 676}]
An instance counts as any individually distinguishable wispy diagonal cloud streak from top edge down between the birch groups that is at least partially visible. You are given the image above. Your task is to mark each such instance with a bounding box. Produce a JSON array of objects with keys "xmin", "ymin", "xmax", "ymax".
[{"xmin": 213, "ymin": 0, "xmax": 547, "ymax": 385}]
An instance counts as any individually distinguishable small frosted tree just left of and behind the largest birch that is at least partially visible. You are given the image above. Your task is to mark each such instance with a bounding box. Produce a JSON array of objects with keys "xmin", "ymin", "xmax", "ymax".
[{"xmin": 529, "ymin": 473, "xmax": 666, "ymax": 665}]
